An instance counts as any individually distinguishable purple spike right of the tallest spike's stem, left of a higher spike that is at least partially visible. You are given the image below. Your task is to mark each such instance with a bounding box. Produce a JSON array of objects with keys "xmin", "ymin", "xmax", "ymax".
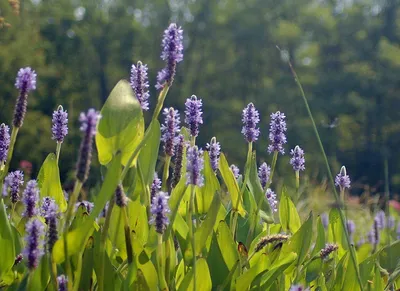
[{"xmin": 161, "ymin": 107, "xmax": 181, "ymax": 157}]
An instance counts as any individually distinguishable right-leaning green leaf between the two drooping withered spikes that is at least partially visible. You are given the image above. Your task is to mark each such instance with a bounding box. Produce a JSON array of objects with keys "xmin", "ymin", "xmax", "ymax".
[{"xmin": 280, "ymin": 213, "xmax": 313, "ymax": 266}]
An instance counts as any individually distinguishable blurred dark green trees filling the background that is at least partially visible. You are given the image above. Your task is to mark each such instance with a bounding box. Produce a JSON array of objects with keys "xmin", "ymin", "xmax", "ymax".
[{"xmin": 0, "ymin": 0, "xmax": 400, "ymax": 196}]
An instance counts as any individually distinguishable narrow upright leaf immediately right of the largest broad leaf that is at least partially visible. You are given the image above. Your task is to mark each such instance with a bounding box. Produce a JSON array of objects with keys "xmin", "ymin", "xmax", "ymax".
[{"xmin": 139, "ymin": 120, "xmax": 161, "ymax": 185}]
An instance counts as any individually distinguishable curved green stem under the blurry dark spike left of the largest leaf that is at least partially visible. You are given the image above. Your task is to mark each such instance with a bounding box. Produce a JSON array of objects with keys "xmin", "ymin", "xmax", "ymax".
[{"xmin": 63, "ymin": 180, "xmax": 82, "ymax": 290}]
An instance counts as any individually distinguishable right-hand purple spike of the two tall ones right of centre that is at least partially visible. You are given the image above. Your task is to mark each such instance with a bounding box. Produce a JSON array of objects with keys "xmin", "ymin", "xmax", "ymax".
[{"xmin": 268, "ymin": 111, "xmax": 287, "ymax": 155}]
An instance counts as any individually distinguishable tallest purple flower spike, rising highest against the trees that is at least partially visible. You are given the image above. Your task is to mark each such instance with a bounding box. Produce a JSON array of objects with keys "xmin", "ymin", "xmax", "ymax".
[{"xmin": 156, "ymin": 23, "xmax": 183, "ymax": 89}]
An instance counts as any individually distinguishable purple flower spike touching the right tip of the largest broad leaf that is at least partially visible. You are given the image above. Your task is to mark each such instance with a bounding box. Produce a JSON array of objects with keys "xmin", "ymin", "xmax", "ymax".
[{"xmin": 131, "ymin": 61, "xmax": 150, "ymax": 110}]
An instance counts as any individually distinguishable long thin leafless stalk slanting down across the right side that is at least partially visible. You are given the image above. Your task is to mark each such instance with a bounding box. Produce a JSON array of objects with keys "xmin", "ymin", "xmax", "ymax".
[{"xmin": 284, "ymin": 54, "xmax": 364, "ymax": 291}]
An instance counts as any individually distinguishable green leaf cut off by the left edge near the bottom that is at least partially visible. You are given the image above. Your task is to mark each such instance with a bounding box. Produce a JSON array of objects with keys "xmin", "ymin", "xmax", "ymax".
[{"xmin": 0, "ymin": 198, "xmax": 15, "ymax": 281}]
